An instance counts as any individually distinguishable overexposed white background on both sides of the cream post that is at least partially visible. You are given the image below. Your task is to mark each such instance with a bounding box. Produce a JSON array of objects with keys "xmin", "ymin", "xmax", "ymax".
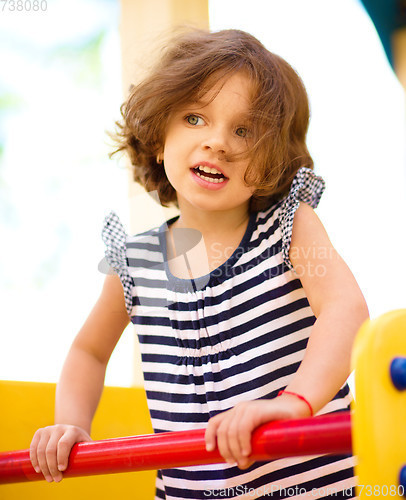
[{"xmin": 0, "ymin": 0, "xmax": 406, "ymax": 386}]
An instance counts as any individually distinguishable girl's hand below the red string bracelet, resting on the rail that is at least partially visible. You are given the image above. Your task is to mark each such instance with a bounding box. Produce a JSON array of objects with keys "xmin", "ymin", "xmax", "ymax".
[{"xmin": 205, "ymin": 394, "xmax": 309, "ymax": 469}]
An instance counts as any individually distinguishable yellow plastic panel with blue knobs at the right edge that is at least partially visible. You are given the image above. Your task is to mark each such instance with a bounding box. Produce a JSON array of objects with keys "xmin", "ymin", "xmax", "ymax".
[{"xmin": 352, "ymin": 309, "xmax": 406, "ymax": 498}]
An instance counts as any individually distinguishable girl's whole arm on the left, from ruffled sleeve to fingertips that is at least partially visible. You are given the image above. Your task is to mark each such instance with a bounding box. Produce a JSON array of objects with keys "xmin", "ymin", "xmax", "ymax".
[{"xmin": 30, "ymin": 275, "xmax": 129, "ymax": 481}]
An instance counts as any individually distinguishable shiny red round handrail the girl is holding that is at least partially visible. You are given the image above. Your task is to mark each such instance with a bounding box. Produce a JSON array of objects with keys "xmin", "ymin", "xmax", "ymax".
[{"xmin": 0, "ymin": 412, "xmax": 352, "ymax": 484}]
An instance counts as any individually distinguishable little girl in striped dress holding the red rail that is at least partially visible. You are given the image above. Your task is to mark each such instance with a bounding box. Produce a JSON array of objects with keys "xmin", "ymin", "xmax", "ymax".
[{"xmin": 31, "ymin": 30, "xmax": 368, "ymax": 500}]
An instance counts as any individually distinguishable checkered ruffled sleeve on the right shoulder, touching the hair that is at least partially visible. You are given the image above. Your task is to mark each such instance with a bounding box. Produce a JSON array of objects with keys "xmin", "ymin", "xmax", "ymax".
[{"xmin": 279, "ymin": 167, "xmax": 326, "ymax": 270}]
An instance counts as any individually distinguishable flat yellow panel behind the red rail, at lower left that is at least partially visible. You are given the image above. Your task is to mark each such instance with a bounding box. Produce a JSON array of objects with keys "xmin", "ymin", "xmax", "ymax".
[{"xmin": 0, "ymin": 381, "xmax": 156, "ymax": 500}]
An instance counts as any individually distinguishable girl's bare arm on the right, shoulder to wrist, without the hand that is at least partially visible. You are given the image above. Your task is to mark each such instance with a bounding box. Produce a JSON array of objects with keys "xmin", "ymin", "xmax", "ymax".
[{"xmin": 280, "ymin": 203, "xmax": 369, "ymax": 412}]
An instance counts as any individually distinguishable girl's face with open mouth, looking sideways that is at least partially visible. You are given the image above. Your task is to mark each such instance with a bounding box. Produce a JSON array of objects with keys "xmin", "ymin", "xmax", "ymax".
[{"xmin": 164, "ymin": 73, "xmax": 254, "ymax": 212}]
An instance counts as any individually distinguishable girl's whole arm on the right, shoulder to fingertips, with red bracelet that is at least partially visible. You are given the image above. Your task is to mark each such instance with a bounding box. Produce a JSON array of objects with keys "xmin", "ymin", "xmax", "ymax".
[{"xmin": 206, "ymin": 203, "xmax": 368, "ymax": 468}]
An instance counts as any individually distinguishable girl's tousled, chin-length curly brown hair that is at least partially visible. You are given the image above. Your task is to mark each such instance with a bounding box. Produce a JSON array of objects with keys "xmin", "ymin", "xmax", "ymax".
[{"xmin": 112, "ymin": 29, "xmax": 313, "ymax": 211}]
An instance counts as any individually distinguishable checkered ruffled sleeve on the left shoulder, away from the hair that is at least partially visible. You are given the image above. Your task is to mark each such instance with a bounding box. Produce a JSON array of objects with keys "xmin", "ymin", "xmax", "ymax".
[{"xmin": 102, "ymin": 212, "xmax": 132, "ymax": 317}]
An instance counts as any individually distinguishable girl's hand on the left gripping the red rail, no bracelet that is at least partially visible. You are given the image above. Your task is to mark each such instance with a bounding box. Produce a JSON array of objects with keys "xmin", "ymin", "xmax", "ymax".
[{"xmin": 30, "ymin": 424, "xmax": 92, "ymax": 483}]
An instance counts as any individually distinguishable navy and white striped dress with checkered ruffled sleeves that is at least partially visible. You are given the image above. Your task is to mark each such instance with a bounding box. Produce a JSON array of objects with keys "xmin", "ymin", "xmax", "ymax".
[{"xmin": 103, "ymin": 168, "xmax": 355, "ymax": 500}]
